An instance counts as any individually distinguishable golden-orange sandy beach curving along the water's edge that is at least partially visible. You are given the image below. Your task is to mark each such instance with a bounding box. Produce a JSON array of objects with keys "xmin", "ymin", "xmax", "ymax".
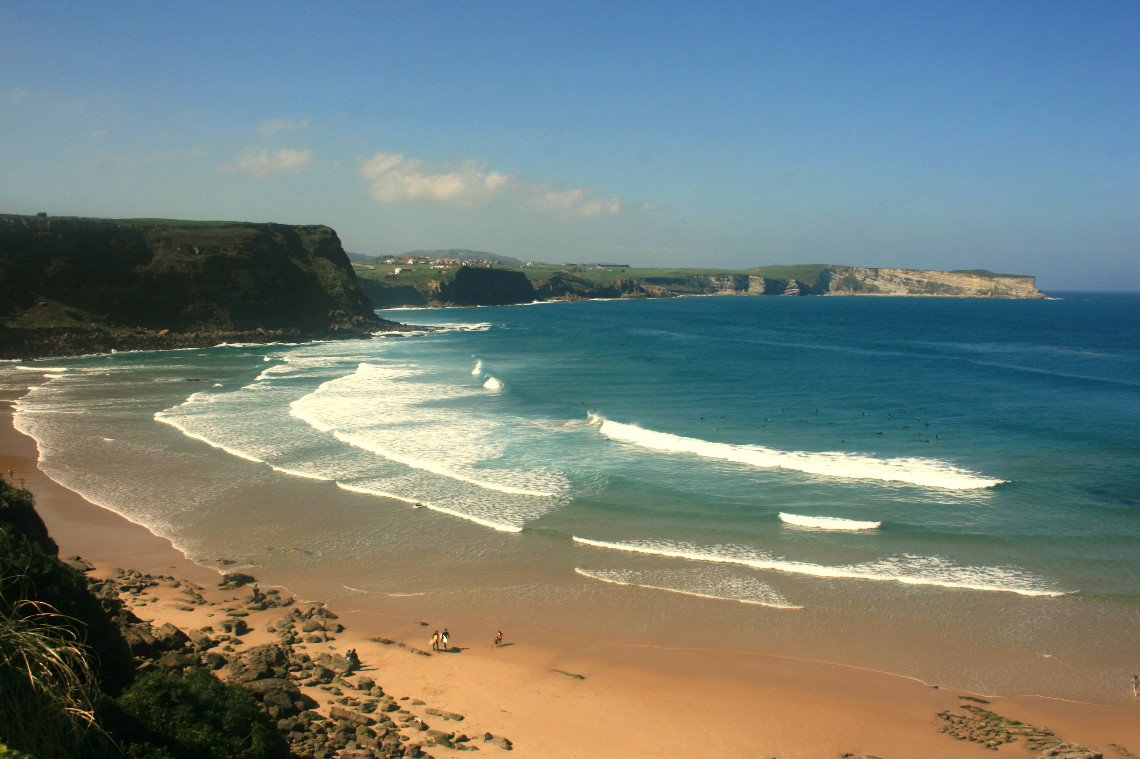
[{"xmin": 0, "ymin": 387, "xmax": 1140, "ymax": 759}]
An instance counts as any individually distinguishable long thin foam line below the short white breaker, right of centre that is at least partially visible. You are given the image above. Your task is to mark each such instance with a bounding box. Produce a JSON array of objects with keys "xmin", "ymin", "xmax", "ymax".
[{"xmin": 573, "ymin": 536, "xmax": 1065, "ymax": 597}]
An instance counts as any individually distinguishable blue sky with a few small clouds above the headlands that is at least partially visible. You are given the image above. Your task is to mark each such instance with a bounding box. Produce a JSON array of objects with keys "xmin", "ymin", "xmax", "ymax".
[{"xmin": 0, "ymin": 0, "xmax": 1140, "ymax": 291}]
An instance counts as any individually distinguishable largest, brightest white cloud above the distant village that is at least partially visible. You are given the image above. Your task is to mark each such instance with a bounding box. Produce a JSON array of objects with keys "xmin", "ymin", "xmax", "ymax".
[{"xmin": 360, "ymin": 153, "xmax": 515, "ymax": 205}]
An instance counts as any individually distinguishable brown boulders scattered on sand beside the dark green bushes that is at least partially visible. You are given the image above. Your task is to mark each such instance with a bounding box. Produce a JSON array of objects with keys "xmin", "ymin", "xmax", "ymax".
[{"xmin": 89, "ymin": 570, "xmax": 512, "ymax": 759}]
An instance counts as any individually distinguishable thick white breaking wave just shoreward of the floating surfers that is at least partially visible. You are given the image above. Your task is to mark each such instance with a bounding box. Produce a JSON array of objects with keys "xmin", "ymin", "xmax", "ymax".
[{"xmin": 591, "ymin": 415, "xmax": 1004, "ymax": 490}]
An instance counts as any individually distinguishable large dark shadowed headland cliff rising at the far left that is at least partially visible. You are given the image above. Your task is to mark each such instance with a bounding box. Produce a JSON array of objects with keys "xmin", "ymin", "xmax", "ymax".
[{"xmin": 0, "ymin": 210, "xmax": 405, "ymax": 358}]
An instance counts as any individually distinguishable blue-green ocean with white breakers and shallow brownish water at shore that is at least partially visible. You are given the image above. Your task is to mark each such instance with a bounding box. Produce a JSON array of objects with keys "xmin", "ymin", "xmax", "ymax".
[{"xmin": 0, "ymin": 293, "xmax": 1140, "ymax": 701}]
